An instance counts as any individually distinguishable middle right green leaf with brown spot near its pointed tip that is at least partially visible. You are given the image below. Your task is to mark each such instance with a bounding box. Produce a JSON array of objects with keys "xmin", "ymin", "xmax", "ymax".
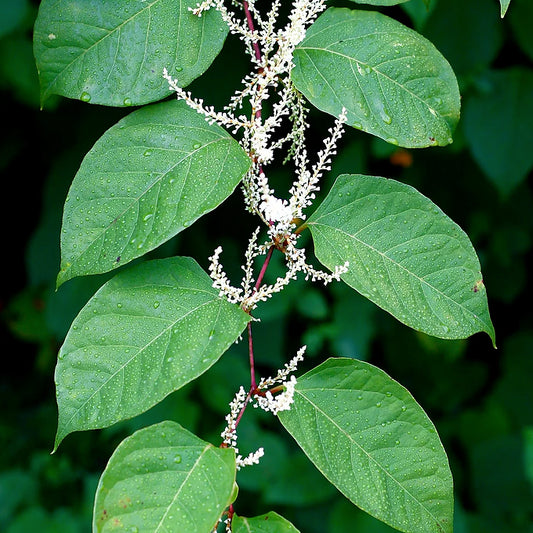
[{"xmin": 307, "ymin": 174, "xmax": 494, "ymax": 342}]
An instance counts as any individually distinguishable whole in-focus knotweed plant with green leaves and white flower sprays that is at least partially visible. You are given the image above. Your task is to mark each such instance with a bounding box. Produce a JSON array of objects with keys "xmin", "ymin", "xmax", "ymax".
[{"xmin": 35, "ymin": 0, "xmax": 498, "ymax": 533}]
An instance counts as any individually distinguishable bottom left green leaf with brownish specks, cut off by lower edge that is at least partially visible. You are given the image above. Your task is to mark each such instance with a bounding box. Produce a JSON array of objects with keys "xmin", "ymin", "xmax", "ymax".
[{"xmin": 93, "ymin": 421, "xmax": 236, "ymax": 533}]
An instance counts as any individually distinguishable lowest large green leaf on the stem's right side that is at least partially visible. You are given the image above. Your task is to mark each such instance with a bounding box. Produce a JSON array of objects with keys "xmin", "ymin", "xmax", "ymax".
[{"xmin": 279, "ymin": 359, "xmax": 453, "ymax": 533}]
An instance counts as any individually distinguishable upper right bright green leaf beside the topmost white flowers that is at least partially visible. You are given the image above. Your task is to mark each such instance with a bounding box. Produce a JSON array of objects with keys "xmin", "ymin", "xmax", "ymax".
[{"xmin": 291, "ymin": 8, "xmax": 460, "ymax": 148}]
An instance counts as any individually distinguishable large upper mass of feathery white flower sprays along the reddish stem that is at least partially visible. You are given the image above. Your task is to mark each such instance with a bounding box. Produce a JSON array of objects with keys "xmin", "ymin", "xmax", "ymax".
[{"xmin": 164, "ymin": 0, "xmax": 348, "ymax": 312}]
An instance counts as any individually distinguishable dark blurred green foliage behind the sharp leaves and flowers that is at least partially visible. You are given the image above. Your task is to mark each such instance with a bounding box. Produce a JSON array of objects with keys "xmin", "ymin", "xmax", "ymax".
[{"xmin": 0, "ymin": 0, "xmax": 533, "ymax": 533}]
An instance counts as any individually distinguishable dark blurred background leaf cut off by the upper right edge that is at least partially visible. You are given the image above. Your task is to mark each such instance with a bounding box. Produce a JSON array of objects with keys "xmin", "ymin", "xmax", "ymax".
[{"xmin": 464, "ymin": 68, "xmax": 533, "ymax": 196}]
